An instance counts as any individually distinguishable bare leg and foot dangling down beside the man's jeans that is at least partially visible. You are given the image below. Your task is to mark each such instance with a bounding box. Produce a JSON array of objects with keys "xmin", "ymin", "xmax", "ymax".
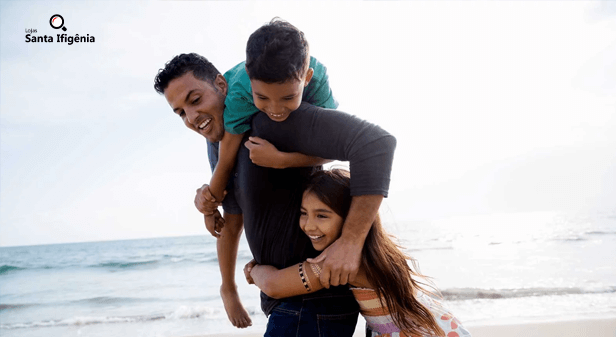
[{"xmin": 216, "ymin": 212, "xmax": 252, "ymax": 328}]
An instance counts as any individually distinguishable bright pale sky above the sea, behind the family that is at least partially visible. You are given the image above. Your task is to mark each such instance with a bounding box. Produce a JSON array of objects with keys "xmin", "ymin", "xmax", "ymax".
[{"xmin": 0, "ymin": 1, "xmax": 616, "ymax": 246}]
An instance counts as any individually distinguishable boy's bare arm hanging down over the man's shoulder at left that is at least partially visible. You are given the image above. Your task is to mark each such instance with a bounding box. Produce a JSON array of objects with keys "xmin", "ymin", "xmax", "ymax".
[{"xmin": 210, "ymin": 131, "xmax": 243, "ymax": 201}]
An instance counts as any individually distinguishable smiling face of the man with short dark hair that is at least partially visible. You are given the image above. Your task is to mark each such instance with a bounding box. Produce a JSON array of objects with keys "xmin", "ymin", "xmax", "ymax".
[{"xmin": 165, "ymin": 71, "xmax": 227, "ymax": 142}]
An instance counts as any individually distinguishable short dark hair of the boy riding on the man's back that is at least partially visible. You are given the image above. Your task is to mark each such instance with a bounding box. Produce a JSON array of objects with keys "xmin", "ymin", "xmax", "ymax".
[{"xmin": 246, "ymin": 17, "xmax": 310, "ymax": 83}]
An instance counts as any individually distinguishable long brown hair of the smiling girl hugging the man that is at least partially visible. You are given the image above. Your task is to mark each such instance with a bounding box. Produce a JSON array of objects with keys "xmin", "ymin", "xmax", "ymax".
[{"xmin": 306, "ymin": 169, "xmax": 445, "ymax": 336}]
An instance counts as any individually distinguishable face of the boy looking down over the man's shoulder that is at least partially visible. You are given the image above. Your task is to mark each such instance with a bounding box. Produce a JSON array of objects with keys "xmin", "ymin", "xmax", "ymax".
[{"xmin": 250, "ymin": 68, "xmax": 314, "ymax": 122}]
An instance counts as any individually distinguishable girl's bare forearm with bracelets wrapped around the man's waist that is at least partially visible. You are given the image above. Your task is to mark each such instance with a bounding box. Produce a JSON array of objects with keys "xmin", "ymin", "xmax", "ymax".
[{"xmin": 244, "ymin": 261, "xmax": 323, "ymax": 299}]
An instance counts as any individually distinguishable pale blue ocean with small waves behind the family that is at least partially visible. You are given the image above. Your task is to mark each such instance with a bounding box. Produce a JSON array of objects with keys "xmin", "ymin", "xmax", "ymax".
[{"xmin": 0, "ymin": 210, "xmax": 616, "ymax": 337}]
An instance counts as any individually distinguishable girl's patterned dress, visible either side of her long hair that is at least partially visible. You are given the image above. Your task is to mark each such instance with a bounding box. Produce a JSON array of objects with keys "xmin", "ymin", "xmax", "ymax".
[{"xmin": 351, "ymin": 288, "xmax": 471, "ymax": 337}]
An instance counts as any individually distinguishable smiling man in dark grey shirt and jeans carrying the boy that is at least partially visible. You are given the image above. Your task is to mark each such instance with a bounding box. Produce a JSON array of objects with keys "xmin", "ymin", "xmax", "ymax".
[{"xmin": 155, "ymin": 54, "xmax": 395, "ymax": 336}]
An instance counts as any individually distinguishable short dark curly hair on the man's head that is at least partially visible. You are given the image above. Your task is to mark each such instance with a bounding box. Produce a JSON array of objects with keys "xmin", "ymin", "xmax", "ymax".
[{"xmin": 154, "ymin": 53, "xmax": 220, "ymax": 94}]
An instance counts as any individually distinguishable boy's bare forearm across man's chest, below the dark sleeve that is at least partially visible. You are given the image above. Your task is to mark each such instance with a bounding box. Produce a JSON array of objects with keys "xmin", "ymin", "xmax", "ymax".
[{"xmin": 246, "ymin": 137, "xmax": 331, "ymax": 169}]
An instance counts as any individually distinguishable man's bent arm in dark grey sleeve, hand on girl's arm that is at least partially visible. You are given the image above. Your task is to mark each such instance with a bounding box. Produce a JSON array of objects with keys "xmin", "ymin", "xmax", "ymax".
[{"xmin": 245, "ymin": 103, "xmax": 396, "ymax": 286}]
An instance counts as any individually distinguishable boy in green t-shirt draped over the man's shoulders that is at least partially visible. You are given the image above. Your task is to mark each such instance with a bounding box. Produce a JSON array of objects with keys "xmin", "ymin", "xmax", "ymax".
[{"xmin": 203, "ymin": 18, "xmax": 338, "ymax": 237}]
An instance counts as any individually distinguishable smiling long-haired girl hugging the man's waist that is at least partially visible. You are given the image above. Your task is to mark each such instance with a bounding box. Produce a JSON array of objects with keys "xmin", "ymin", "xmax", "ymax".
[{"xmin": 244, "ymin": 169, "xmax": 470, "ymax": 337}]
